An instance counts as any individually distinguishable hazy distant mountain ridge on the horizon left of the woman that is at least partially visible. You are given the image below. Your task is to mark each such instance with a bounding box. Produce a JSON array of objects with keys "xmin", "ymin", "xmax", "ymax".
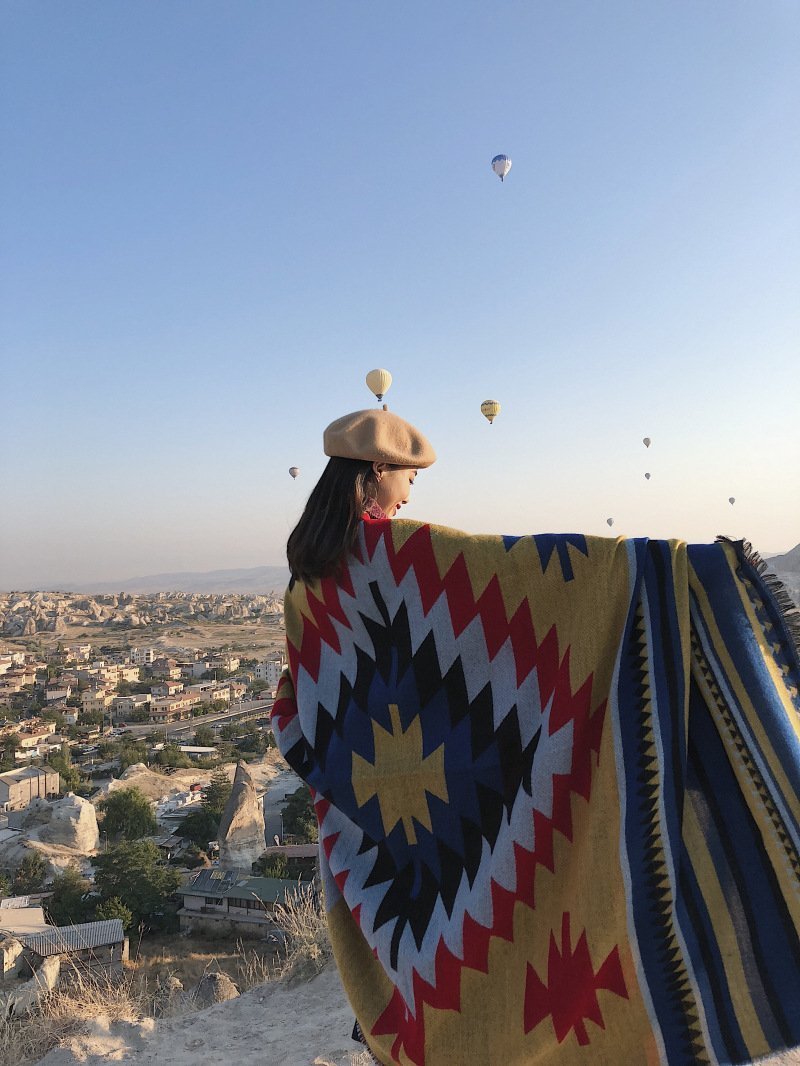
[{"xmin": 59, "ymin": 566, "xmax": 289, "ymax": 595}]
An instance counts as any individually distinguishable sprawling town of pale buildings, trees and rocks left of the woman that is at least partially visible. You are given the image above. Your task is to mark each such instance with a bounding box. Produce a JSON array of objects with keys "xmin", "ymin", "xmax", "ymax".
[{"xmin": 0, "ymin": 618, "xmax": 317, "ymax": 1048}]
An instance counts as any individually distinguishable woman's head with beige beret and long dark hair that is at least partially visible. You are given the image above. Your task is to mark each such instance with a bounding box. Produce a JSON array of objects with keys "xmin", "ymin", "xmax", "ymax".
[{"xmin": 286, "ymin": 407, "xmax": 436, "ymax": 581}]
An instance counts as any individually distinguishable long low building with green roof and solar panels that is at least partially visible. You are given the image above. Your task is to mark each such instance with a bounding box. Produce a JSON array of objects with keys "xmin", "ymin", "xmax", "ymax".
[{"xmin": 178, "ymin": 867, "xmax": 314, "ymax": 937}]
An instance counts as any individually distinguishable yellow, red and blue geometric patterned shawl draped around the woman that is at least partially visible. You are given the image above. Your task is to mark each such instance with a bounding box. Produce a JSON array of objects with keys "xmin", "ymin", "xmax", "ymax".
[{"xmin": 273, "ymin": 520, "xmax": 800, "ymax": 1066}]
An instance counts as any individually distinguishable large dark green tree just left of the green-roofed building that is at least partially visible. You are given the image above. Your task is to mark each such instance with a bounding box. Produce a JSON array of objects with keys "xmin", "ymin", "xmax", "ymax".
[{"xmin": 94, "ymin": 840, "xmax": 180, "ymax": 928}]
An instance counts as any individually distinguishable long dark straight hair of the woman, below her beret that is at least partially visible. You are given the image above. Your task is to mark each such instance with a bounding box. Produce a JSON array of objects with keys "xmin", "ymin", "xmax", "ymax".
[{"xmin": 286, "ymin": 457, "xmax": 386, "ymax": 581}]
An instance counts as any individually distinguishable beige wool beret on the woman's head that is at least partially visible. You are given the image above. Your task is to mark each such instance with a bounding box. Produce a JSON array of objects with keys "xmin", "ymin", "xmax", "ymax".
[{"xmin": 322, "ymin": 409, "xmax": 436, "ymax": 470}]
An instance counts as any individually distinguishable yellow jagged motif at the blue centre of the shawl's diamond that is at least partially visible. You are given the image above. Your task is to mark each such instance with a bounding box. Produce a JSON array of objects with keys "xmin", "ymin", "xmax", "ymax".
[{"xmin": 352, "ymin": 704, "xmax": 448, "ymax": 844}]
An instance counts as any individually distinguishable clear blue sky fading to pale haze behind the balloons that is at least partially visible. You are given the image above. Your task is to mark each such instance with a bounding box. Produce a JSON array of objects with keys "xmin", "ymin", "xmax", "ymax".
[{"xmin": 0, "ymin": 0, "xmax": 800, "ymax": 588}]
